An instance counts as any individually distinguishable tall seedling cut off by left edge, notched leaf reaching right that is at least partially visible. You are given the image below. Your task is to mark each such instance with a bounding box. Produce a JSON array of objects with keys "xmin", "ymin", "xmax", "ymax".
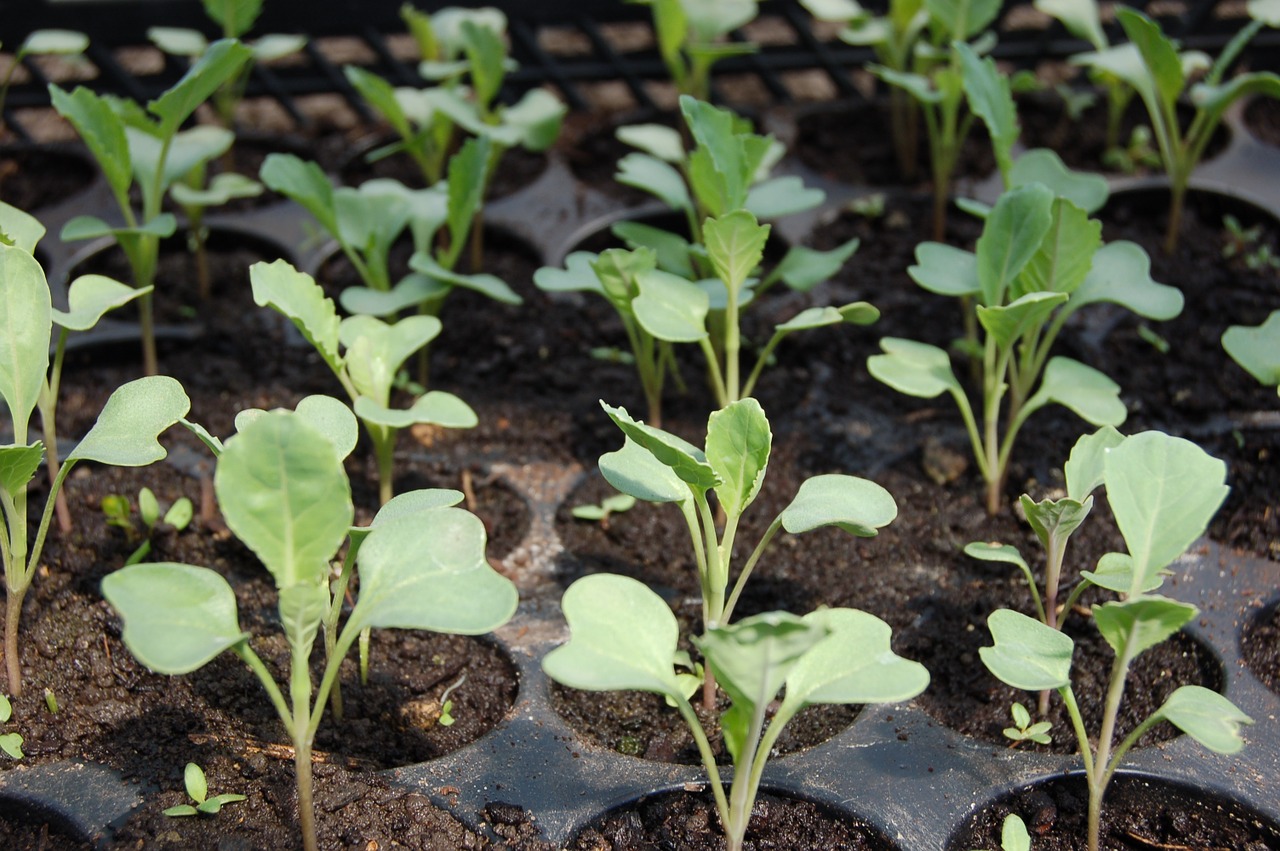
[{"xmin": 0, "ymin": 234, "xmax": 191, "ymax": 696}]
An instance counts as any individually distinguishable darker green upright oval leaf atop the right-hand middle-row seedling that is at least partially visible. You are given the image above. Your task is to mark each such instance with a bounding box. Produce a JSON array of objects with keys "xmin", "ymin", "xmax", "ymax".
[{"xmin": 977, "ymin": 183, "xmax": 1053, "ymax": 307}]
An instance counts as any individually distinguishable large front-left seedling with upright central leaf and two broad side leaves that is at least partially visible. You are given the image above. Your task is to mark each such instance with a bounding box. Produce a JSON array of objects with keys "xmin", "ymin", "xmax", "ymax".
[{"xmin": 102, "ymin": 411, "xmax": 516, "ymax": 851}]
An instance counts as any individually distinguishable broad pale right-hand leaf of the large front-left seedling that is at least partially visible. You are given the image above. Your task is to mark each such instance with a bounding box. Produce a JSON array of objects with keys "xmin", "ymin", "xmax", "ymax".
[{"xmin": 346, "ymin": 508, "xmax": 517, "ymax": 635}]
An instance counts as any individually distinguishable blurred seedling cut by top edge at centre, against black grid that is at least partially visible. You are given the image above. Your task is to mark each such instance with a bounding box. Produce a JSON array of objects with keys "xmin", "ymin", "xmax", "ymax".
[{"xmin": 627, "ymin": 0, "xmax": 760, "ymax": 101}]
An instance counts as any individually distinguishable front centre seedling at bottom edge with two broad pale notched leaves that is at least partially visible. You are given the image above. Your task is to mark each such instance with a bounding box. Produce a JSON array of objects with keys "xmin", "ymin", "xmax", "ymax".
[{"xmin": 543, "ymin": 573, "xmax": 929, "ymax": 851}]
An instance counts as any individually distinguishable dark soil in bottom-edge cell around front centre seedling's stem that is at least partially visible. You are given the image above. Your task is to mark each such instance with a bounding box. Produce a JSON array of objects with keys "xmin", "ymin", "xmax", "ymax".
[{"xmin": 568, "ymin": 792, "xmax": 896, "ymax": 851}]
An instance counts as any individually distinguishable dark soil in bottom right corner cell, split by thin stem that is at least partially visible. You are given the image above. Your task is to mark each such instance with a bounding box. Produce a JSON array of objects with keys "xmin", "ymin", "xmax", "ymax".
[{"xmin": 947, "ymin": 774, "xmax": 1280, "ymax": 851}]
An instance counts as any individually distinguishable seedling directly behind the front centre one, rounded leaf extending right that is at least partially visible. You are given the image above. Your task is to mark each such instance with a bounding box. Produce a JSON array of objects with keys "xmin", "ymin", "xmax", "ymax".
[{"xmin": 600, "ymin": 399, "xmax": 897, "ymax": 708}]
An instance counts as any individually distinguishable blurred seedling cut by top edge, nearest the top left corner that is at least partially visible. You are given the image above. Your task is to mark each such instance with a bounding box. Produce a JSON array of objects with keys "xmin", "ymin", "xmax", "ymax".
[{"xmin": 147, "ymin": 0, "xmax": 307, "ymax": 129}]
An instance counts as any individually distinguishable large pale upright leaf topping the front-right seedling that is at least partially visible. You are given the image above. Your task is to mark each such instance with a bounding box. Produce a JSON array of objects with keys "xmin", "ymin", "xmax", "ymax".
[{"xmin": 1105, "ymin": 431, "xmax": 1230, "ymax": 593}]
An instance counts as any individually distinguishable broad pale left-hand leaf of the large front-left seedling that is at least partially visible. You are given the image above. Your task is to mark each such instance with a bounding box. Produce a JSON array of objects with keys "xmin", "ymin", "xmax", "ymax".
[{"xmin": 102, "ymin": 562, "xmax": 250, "ymax": 674}]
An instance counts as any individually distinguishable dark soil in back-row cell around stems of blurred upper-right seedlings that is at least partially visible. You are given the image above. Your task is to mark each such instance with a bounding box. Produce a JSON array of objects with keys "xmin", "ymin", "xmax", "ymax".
[{"xmin": 792, "ymin": 100, "xmax": 996, "ymax": 188}]
